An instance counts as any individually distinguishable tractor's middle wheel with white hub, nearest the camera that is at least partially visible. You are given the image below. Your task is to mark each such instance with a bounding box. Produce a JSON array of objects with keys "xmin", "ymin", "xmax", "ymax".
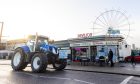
[{"xmin": 31, "ymin": 53, "xmax": 48, "ymax": 73}]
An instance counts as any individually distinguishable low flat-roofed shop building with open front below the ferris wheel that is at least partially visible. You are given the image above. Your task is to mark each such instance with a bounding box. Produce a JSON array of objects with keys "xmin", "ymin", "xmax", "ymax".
[{"xmin": 54, "ymin": 35, "xmax": 131, "ymax": 62}]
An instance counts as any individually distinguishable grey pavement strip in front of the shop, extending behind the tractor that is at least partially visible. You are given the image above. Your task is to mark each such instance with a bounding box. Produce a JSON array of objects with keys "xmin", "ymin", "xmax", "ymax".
[{"xmin": 0, "ymin": 60, "xmax": 140, "ymax": 77}]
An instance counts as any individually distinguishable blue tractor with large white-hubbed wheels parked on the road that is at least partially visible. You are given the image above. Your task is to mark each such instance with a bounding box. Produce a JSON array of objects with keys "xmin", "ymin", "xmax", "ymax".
[{"xmin": 11, "ymin": 35, "xmax": 67, "ymax": 73}]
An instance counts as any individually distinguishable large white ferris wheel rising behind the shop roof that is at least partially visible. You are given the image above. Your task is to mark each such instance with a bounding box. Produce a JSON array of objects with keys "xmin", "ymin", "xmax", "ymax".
[{"xmin": 93, "ymin": 10, "xmax": 130, "ymax": 39}]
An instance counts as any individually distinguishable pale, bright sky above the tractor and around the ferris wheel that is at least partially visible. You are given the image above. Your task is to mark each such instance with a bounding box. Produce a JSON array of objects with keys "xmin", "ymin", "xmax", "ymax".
[{"xmin": 0, "ymin": 0, "xmax": 140, "ymax": 47}]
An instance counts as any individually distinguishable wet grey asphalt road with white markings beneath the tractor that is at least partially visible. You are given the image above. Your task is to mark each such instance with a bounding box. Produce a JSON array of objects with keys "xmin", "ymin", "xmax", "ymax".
[{"xmin": 0, "ymin": 65, "xmax": 140, "ymax": 84}]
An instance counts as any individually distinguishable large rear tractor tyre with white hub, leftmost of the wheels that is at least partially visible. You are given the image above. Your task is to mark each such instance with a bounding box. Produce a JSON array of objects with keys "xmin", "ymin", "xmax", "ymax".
[{"xmin": 11, "ymin": 48, "xmax": 28, "ymax": 71}]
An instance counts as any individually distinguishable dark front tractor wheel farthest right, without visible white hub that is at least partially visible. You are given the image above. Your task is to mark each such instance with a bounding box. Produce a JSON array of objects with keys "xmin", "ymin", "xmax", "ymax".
[{"xmin": 53, "ymin": 59, "xmax": 67, "ymax": 71}]
